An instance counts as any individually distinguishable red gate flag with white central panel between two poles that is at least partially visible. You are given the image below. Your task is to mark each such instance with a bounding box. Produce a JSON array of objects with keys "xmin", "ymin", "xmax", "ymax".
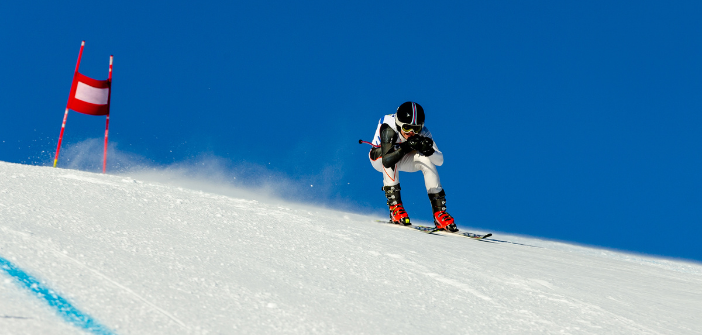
[{"xmin": 68, "ymin": 72, "xmax": 111, "ymax": 115}]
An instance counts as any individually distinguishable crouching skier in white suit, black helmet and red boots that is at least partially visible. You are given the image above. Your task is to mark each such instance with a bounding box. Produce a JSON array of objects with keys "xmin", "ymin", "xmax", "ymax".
[{"xmin": 368, "ymin": 101, "xmax": 458, "ymax": 232}]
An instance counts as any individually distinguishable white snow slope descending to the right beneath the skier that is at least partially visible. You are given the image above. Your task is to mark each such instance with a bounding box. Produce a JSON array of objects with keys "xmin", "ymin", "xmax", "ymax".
[{"xmin": 0, "ymin": 162, "xmax": 702, "ymax": 334}]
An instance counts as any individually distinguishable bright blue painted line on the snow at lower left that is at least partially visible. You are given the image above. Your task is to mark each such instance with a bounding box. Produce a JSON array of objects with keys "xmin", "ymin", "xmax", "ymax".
[{"xmin": 0, "ymin": 257, "xmax": 114, "ymax": 335}]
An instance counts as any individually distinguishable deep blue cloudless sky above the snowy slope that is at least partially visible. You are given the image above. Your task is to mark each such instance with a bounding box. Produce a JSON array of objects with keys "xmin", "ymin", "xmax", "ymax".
[{"xmin": 0, "ymin": 1, "xmax": 702, "ymax": 260}]
